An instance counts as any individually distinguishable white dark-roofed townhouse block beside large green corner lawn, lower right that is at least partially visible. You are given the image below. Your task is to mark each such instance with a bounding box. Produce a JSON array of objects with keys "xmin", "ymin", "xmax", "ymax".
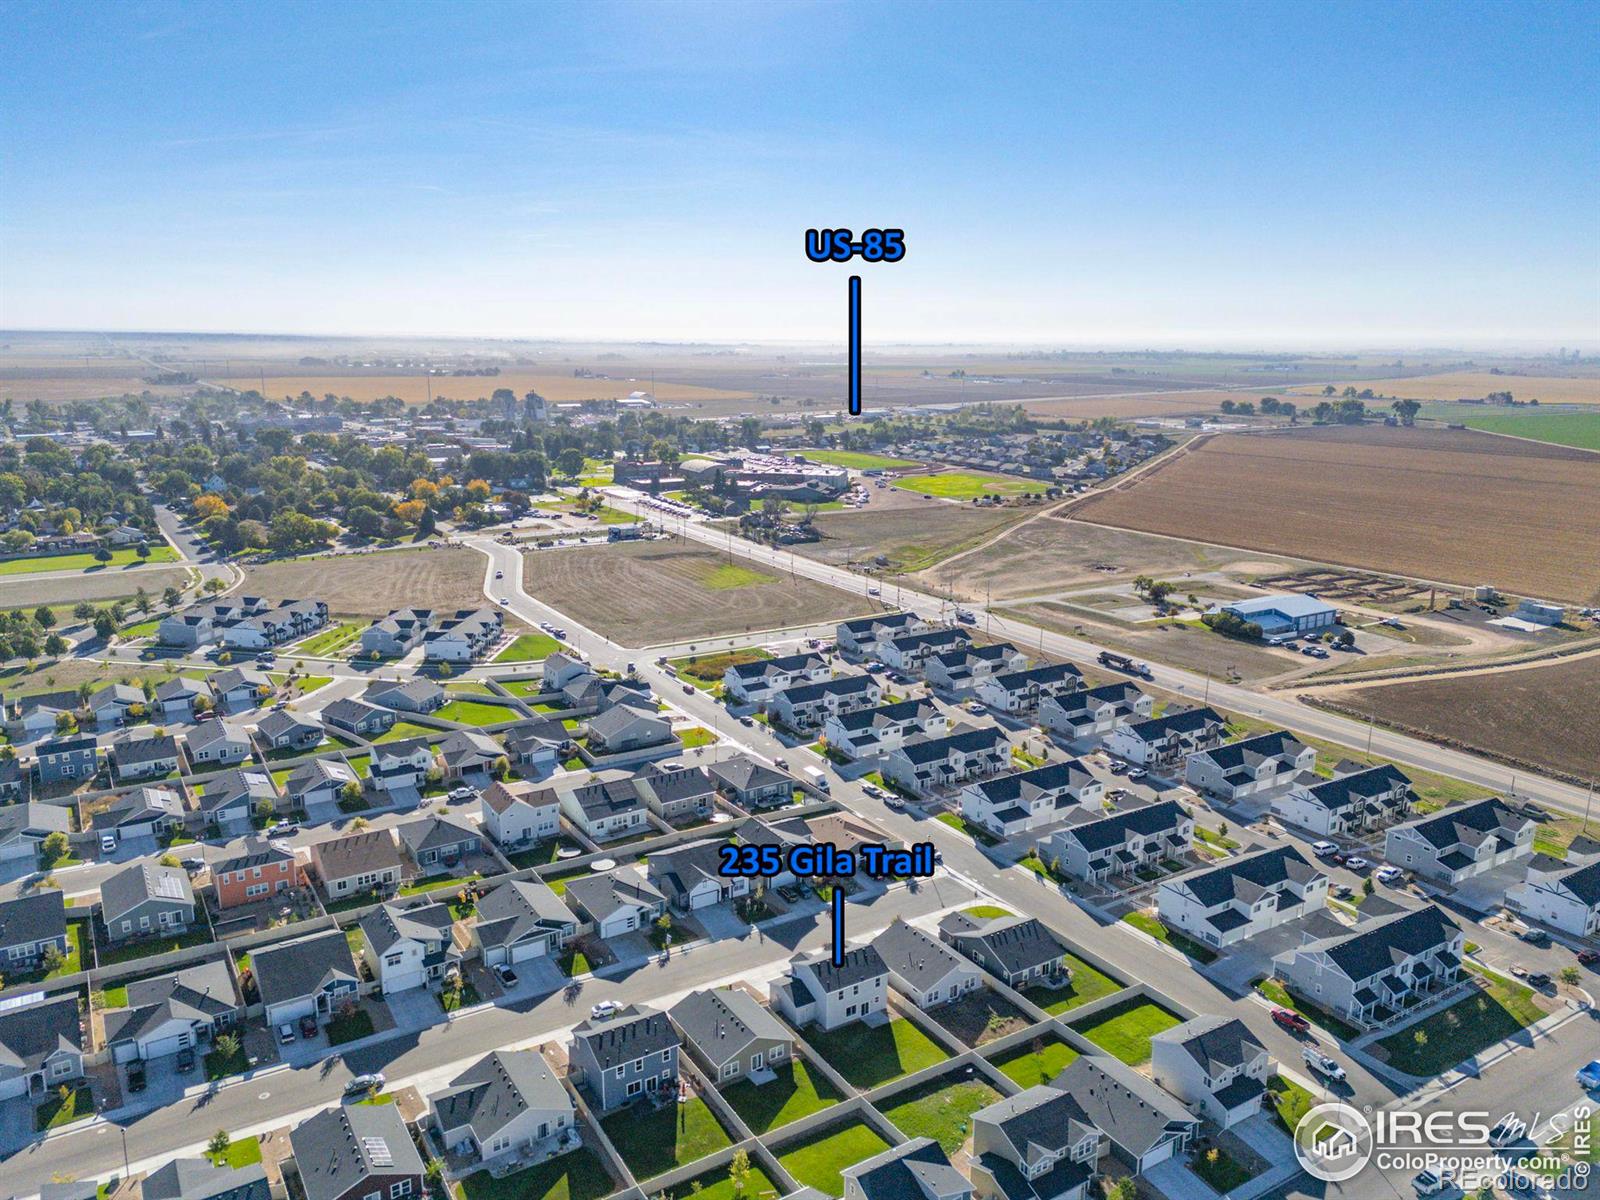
[{"xmin": 1272, "ymin": 904, "xmax": 1466, "ymax": 1022}]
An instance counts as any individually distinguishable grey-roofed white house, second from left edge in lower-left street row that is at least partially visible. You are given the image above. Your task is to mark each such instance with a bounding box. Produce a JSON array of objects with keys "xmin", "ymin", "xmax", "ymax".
[{"xmin": 104, "ymin": 958, "xmax": 243, "ymax": 1062}]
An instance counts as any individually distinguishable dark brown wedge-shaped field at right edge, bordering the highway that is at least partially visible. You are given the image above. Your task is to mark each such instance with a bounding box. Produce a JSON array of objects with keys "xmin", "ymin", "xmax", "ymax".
[{"xmin": 1326, "ymin": 656, "xmax": 1600, "ymax": 781}]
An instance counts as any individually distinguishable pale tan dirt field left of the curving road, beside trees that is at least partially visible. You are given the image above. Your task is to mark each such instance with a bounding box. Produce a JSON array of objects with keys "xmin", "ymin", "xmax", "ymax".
[{"xmin": 240, "ymin": 549, "xmax": 486, "ymax": 616}]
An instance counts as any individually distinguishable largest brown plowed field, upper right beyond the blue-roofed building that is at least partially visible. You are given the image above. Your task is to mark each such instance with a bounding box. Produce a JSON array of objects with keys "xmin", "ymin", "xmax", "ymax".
[{"xmin": 1075, "ymin": 426, "xmax": 1600, "ymax": 603}]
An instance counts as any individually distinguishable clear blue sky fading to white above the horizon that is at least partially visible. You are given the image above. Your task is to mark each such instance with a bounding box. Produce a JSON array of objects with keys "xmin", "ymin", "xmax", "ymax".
[{"xmin": 0, "ymin": 0, "xmax": 1600, "ymax": 349}]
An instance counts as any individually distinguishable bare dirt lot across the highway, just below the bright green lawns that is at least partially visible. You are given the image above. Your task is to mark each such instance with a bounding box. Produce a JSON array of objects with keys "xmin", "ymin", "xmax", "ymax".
[{"xmin": 794, "ymin": 502, "xmax": 1037, "ymax": 571}]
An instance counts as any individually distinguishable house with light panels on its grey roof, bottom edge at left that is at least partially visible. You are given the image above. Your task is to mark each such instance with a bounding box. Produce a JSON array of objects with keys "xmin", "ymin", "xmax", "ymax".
[{"xmin": 290, "ymin": 1104, "xmax": 426, "ymax": 1200}]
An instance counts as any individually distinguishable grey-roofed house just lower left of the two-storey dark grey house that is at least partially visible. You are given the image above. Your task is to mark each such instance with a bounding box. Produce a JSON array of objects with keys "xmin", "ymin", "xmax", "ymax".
[{"xmin": 427, "ymin": 1050, "xmax": 578, "ymax": 1163}]
